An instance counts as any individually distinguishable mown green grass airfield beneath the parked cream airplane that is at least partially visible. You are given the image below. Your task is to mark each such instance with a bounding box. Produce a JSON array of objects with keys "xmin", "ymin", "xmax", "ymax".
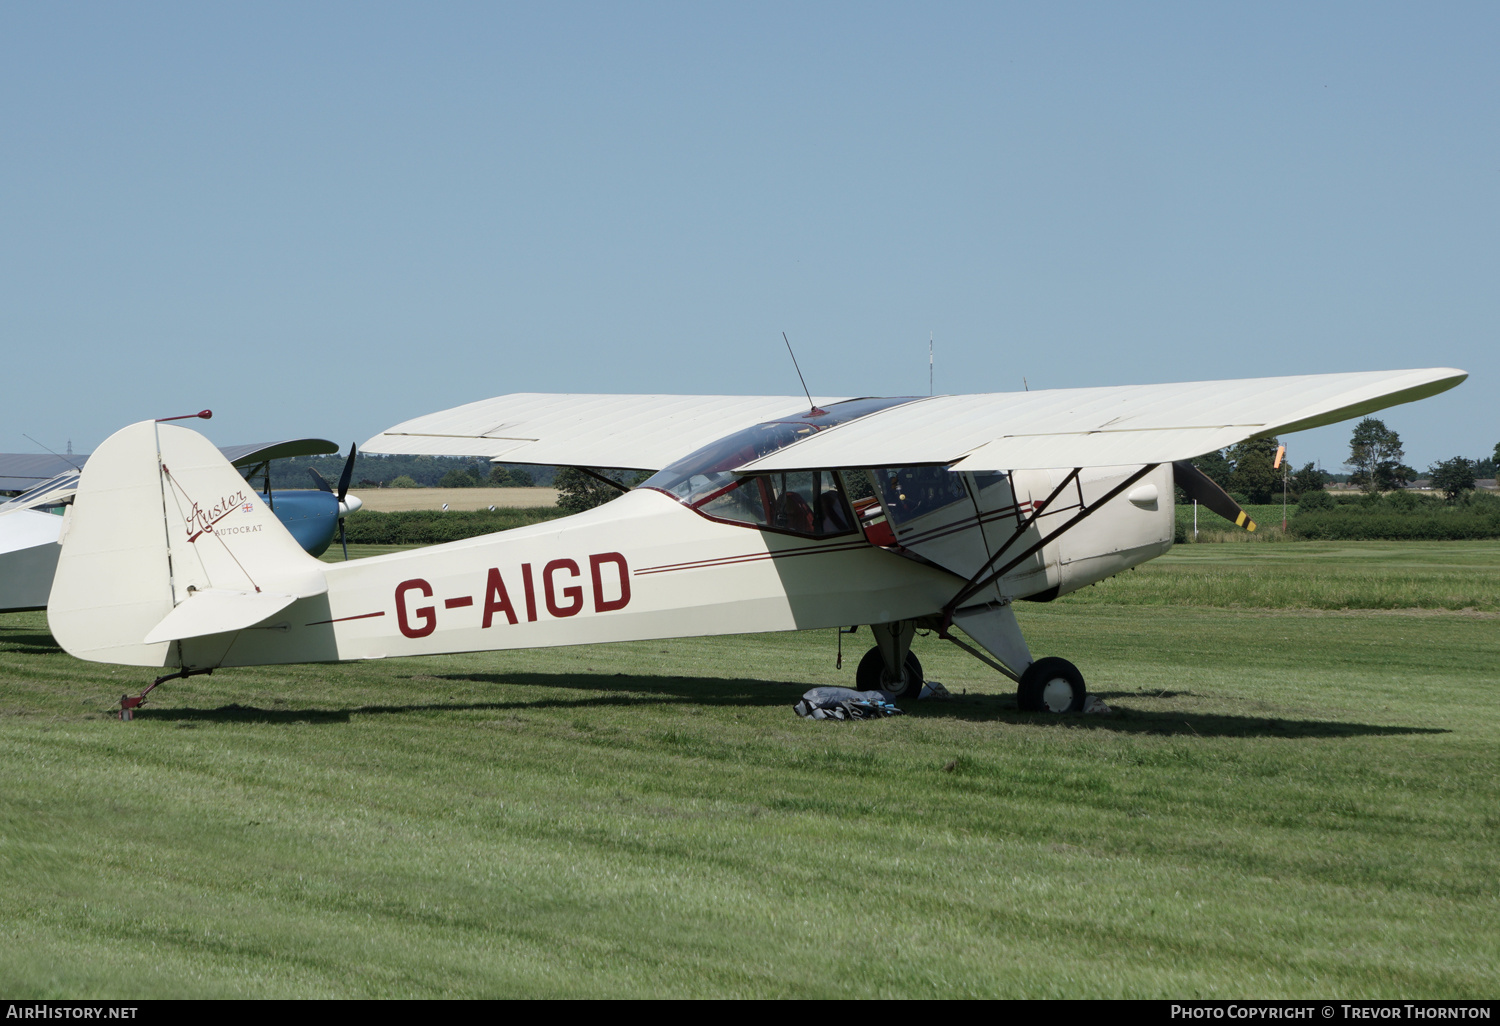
[{"xmin": 0, "ymin": 543, "xmax": 1500, "ymax": 998}]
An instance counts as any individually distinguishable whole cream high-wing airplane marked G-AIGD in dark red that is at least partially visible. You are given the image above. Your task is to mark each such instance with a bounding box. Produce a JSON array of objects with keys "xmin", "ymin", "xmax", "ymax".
[{"xmin": 48, "ymin": 368, "xmax": 1467, "ymax": 711}]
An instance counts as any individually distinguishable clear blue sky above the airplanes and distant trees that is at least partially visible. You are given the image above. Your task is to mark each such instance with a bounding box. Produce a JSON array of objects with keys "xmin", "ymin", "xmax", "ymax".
[{"xmin": 0, "ymin": 2, "xmax": 1500, "ymax": 468}]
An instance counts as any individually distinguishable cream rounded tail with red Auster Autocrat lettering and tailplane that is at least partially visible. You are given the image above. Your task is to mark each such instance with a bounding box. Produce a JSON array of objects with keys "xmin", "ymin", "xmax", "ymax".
[{"xmin": 47, "ymin": 422, "xmax": 327, "ymax": 666}]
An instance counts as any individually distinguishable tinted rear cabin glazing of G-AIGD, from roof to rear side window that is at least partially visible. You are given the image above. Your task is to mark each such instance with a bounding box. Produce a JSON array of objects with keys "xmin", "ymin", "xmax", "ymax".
[{"xmin": 642, "ymin": 399, "xmax": 911, "ymax": 537}]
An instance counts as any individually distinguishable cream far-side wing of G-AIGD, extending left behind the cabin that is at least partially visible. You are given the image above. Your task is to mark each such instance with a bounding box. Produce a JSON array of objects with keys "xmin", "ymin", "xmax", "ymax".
[{"xmin": 360, "ymin": 392, "xmax": 840, "ymax": 470}]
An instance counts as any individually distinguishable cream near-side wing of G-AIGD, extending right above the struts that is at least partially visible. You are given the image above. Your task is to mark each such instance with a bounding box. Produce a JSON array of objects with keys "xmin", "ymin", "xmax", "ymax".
[{"xmin": 737, "ymin": 368, "xmax": 1469, "ymax": 474}]
